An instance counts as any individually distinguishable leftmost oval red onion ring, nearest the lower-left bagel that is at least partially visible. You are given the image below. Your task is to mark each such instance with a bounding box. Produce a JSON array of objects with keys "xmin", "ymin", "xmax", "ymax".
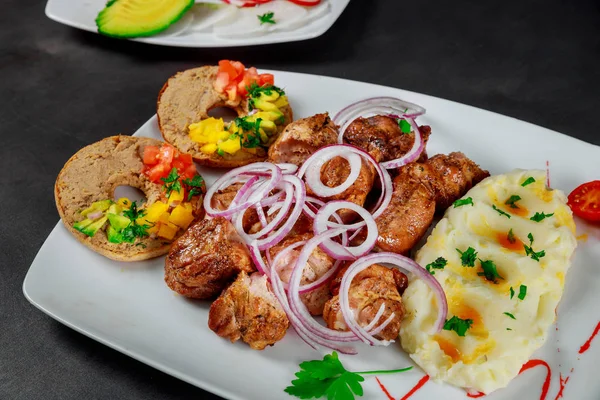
[{"xmin": 204, "ymin": 162, "xmax": 283, "ymax": 217}]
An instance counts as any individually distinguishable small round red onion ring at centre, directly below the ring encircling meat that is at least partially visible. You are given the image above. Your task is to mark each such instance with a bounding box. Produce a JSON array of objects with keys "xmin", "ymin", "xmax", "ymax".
[{"xmin": 313, "ymin": 200, "xmax": 378, "ymax": 260}]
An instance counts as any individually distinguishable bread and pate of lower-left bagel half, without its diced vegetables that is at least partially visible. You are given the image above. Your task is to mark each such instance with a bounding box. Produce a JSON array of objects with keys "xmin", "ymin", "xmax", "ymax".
[{"xmin": 54, "ymin": 136, "xmax": 199, "ymax": 261}]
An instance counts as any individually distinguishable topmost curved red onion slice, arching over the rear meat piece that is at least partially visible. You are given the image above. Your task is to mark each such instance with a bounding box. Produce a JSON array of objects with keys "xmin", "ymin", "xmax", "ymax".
[{"xmin": 333, "ymin": 97, "xmax": 426, "ymax": 137}]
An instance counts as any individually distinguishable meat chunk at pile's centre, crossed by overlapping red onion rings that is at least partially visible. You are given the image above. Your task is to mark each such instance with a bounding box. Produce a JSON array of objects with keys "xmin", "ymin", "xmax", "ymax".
[{"xmin": 268, "ymin": 233, "xmax": 335, "ymax": 315}]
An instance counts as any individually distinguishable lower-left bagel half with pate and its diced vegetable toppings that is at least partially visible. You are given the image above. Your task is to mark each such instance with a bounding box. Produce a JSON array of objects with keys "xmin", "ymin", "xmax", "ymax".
[{"xmin": 54, "ymin": 136, "xmax": 205, "ymax": 261}]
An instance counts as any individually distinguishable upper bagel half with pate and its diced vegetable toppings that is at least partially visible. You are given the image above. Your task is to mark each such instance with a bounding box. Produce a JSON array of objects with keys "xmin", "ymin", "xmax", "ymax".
[{"xmin": 157, "ymin": 60, "xmax": 293, "ymax": 168}]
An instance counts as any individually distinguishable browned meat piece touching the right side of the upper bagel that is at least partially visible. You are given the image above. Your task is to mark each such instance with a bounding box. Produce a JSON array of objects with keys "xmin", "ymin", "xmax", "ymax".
[{"xmin": 269, "ymin": 113, "xmax": 338, "ymax": 166}]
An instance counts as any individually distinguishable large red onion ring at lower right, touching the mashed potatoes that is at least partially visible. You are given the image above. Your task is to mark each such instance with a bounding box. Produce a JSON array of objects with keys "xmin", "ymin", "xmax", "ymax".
[{"xmin": 339, "ymin": 253, "xmax": 448, "ymax": 336}]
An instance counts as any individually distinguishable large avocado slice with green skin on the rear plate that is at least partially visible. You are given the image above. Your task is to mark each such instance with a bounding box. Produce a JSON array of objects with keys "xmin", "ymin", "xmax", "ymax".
[{"xmin": 96, "ymin": 0, "xmax": 194, "ymax": 38}]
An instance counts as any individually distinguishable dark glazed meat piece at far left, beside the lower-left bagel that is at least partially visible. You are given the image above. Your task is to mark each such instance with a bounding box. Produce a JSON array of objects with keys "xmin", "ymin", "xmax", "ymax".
[{"xmin": 165, "ymin": 217, "xmax": 255, "ymax": 299}]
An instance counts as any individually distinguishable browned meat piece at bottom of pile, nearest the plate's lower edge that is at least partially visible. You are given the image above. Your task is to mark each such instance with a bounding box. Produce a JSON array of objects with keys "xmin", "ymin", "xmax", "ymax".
[{"xmin": 208, "ymin": 271, "xmax": 289, "ymax": 350}]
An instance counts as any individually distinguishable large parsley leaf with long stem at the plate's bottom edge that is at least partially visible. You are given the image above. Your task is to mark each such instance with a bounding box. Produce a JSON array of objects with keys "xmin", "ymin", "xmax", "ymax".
[{"xmin": 284, "ymin": 351, "xmax": 412, "ymax": 400}]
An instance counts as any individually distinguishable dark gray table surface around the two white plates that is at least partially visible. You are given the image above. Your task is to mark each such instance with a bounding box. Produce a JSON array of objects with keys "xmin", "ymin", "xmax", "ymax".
[{"xmin": 0, "ymin": 0, "xmax": 600, "ymax": 400}]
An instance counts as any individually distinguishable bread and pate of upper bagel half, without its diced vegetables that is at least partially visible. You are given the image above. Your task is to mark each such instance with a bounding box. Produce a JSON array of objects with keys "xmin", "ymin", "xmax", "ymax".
[{"xmin": 157, "ymin": 66, "xmax": 293, "ymax": 168}]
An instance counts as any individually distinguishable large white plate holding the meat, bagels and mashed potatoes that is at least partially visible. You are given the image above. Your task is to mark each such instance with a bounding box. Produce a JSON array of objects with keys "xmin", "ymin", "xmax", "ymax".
[{"xmin": 23, "ymin": 71, "xmax": 600, "ymax": 400}]
